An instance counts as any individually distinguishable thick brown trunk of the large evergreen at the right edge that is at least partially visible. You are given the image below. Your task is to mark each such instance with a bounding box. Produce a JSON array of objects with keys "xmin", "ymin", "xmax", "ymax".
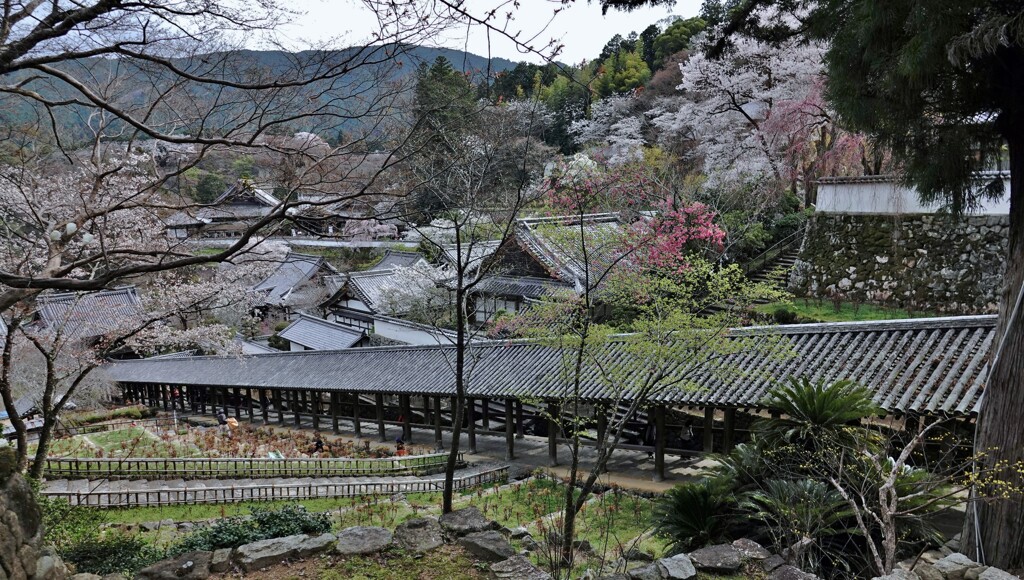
[{"xmin": 964, "ymin": 126, "xmax": 1024, "ymax": 570}]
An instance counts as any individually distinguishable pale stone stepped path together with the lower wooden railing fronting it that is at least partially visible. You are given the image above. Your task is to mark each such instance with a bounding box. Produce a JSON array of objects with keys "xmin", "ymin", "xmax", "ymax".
[{"xmin": 41, "ymin": 462, "xmax": 508, "ymax": 507}]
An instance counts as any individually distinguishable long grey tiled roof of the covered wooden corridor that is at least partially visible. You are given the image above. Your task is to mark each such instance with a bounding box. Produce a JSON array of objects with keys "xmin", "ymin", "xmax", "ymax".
[{"xmin": 109, "ymin": 316, "xmax": 995, "ymax": 415}]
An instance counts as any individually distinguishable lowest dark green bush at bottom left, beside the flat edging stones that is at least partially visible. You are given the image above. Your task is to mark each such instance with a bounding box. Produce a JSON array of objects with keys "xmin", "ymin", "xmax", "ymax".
[{"xmin": 59, "ymin": 534, "xmax": 164, "ymax": 576}]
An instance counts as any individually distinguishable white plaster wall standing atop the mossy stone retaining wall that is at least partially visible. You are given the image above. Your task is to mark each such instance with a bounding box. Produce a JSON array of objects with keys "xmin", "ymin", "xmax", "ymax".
[{"xmin": 815, "ymin": 175, "xmax": 1010, "ymax": 215}]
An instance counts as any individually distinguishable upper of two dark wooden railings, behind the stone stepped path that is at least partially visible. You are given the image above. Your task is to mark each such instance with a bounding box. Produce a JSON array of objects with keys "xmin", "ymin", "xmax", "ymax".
[{"xmin": 43, "ymin": 453, "xmax": 465, "ymax": 480}]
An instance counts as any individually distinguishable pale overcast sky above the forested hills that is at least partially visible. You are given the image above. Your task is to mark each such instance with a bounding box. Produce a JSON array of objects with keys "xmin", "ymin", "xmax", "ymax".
[{"xmin": 280, "ymin": 0, "xmax": 701, "ymax": 64}]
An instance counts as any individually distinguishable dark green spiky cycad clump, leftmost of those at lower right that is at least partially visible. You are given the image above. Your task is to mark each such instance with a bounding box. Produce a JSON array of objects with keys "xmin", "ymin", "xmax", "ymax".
[{"xmin": 653, "ymin": 479, "xmax": 737, "ymax": 553}]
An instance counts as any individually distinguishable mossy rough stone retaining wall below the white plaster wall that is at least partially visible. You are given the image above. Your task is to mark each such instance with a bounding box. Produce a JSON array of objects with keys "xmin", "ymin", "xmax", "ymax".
[{"xmin": 790, "ymin": 213, "xmax": 1010, "ymax": 314}]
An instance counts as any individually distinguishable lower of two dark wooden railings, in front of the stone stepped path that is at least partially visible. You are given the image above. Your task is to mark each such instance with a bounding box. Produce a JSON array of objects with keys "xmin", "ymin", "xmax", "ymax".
[{"xmin": 41, "ymin": 466, "xmax": 508, "ymax": 508}]
